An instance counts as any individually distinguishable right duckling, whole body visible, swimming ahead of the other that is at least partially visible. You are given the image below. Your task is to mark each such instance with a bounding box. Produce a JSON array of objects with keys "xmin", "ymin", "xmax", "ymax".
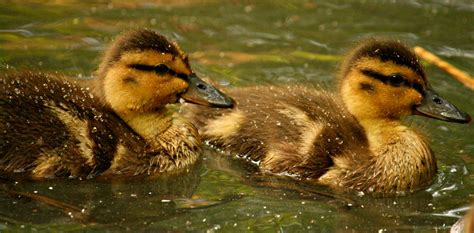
[{"xmin": 181, "ymin": 38, "xmax": 470, "ymax": 194}]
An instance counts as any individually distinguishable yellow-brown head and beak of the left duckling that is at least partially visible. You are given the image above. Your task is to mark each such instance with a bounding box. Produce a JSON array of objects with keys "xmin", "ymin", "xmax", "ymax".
[{"xmin": 96, "ymin": 29, "xmax": 233, "ymax": 114}]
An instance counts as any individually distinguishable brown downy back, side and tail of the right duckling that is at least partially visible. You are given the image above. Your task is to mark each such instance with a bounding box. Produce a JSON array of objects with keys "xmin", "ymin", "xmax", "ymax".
[{"xmin": 183, "ymin": 86, "xmax": 370, "ymax": 179}]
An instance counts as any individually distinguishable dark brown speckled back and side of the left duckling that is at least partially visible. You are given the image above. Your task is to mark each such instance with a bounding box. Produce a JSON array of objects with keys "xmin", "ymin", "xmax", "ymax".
[{"xmin": 0, "ymin": 72, "xmax": 140, "ymax": 177}]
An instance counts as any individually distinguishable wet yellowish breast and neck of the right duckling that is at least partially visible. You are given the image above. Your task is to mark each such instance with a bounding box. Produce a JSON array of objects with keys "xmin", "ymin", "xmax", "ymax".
[{"xmin": 349, "ymin": 119, "xmax": 436, "ymax": 193}]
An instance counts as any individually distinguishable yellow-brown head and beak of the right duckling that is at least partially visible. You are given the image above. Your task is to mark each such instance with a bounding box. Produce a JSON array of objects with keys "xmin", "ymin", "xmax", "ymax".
[{"xmin": 339, "ymin": 39, "xmax": 471, "ymax": 123}]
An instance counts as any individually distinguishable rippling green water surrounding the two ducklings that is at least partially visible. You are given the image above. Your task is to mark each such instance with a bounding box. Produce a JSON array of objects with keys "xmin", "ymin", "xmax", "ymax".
[{"xmin": 0, "ymin": 0, "xmax": 474, "ymax": 232}]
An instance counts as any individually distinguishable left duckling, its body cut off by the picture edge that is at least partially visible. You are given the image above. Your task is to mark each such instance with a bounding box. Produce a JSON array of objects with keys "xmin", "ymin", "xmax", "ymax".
[{"xmin": 0, "ymin": 29, "xmax": 233, "ymax": 179}]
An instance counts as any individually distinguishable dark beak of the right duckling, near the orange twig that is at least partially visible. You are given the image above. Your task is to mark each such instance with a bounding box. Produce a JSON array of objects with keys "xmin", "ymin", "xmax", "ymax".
[{"xmin": 415, "ymin": 88, "xmax": 471, "ymax": 123}]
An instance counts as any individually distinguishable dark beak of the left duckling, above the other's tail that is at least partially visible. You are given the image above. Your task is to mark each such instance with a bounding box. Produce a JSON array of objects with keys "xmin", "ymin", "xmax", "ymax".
[{"xmin": 181, "ymin": 74, "xmax": 234, "ymax": 108}]
